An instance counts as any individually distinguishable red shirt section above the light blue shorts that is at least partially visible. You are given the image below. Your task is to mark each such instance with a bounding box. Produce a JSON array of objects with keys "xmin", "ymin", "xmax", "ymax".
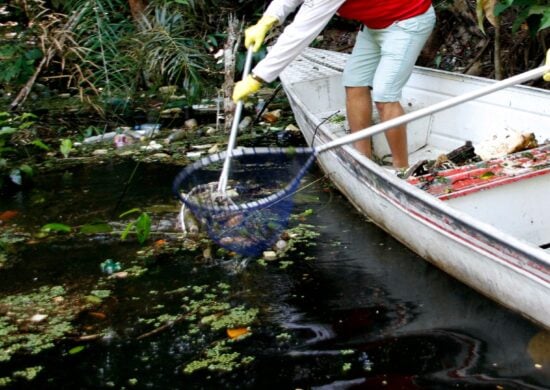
[{"xmin": 338, "ymin": 0, "xmax": 432, "ymax": 29}]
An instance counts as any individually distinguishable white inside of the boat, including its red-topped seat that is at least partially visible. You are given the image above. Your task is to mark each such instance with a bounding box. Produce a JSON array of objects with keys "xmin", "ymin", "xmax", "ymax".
[{"xmin": 285, "ymin": 51, "xmax": 550, "ymax": 253}]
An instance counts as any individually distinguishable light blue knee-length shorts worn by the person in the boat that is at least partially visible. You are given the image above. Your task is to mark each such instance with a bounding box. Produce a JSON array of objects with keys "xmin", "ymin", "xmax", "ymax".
[{"xmin": 342, "ymin": 7, "xmax": 435, "ymax": 102}]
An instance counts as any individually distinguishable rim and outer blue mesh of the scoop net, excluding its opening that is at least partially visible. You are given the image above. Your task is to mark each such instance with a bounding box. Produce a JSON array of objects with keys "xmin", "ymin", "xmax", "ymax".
[{"xmin": 172, "ymin": 147, "xmax": 316, "ymax": 256}]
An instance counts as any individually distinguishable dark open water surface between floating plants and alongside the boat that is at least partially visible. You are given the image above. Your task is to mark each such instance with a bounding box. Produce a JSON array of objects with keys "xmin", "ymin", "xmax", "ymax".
[{"xmin": 0, "ymin": 164, "xmax": 550, "ymax": 389}]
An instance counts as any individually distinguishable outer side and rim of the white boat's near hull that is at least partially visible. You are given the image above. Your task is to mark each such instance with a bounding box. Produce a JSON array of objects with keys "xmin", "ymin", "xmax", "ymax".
[{"xmin": 281, "ymin": 48, "xmax": 550, "ymax": 329}]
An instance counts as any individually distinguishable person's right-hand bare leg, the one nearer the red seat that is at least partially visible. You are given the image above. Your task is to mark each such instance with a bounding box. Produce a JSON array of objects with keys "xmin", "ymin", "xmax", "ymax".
[{"xmin": 375, "ymin": 102, "xmax": 409, "ymax": 168}]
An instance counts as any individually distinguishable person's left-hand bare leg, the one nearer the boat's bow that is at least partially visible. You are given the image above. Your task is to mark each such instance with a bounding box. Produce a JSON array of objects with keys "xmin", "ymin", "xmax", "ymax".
[{"xmin": 346, "ymin": 87, "xmax": 372, "ymax": 158}]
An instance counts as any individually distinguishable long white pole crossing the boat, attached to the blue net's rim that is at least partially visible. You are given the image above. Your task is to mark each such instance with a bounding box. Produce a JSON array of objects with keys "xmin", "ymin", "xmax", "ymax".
[{"xmin": 315, "ymin": 60, "xmax": 550, "ymax": 154}]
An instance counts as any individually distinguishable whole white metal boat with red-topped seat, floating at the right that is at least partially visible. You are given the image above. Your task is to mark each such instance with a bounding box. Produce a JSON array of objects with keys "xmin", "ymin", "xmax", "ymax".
[{"xmin": 280, "ymin": 49, "xmax": 550, "ymax": 329}]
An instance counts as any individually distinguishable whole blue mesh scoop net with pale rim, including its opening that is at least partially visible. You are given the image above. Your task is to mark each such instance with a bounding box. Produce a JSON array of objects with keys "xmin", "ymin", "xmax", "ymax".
[{"xmin": 173, "ymin": 148, "xmax": 315, "ymax": 256}]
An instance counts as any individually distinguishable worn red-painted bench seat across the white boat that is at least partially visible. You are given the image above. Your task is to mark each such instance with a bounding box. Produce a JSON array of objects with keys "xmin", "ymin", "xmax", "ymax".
[{"xmin": 407, "ymin": 144, "xmax": 550, "ymax": 200}]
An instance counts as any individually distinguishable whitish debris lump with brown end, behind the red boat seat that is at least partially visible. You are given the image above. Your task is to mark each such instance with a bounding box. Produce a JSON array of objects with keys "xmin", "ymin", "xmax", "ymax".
[{"xmin": 475, "ymin": 130, "xmax": 538, "ymax": 161}]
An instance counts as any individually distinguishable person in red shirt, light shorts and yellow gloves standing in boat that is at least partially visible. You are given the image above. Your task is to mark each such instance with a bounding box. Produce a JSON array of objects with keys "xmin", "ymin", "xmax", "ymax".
[{"xmin": 232, "ymin": 0, "xmax": 436, "ymax": 168}]
